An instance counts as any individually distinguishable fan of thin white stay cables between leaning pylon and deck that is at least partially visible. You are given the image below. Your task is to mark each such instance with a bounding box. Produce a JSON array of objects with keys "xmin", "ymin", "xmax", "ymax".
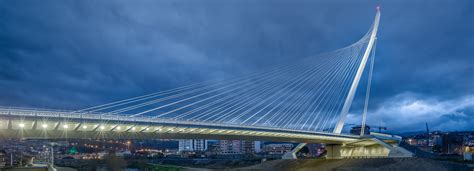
[{"xmin": 76, "ymin": 24, "xmax": 380, "ymax": 132}]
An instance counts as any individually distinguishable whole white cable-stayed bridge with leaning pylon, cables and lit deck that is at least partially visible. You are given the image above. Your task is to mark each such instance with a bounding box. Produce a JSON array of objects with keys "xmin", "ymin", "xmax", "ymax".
[{"xmin": 0, "ymin": 10, "xmax": 412, "ymax": 157}]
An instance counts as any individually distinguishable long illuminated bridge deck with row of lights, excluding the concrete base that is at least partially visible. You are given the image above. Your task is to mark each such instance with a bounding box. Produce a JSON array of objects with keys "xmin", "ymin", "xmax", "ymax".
[{"xmin": 0, "ymin": 109, "xmax": 360, "ymax": 144}]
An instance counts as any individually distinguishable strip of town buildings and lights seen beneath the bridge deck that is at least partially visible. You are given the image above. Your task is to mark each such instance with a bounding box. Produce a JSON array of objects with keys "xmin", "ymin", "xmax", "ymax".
[{"xmin": 0, "ymin": 139, "xmax": 330, "ymax": 168}]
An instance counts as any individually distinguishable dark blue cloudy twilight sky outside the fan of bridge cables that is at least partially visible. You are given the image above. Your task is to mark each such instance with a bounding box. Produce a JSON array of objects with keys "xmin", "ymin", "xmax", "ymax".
[{"xmin": 0, "ymin": 0, "xmax": 474, "ymax": 132}]
